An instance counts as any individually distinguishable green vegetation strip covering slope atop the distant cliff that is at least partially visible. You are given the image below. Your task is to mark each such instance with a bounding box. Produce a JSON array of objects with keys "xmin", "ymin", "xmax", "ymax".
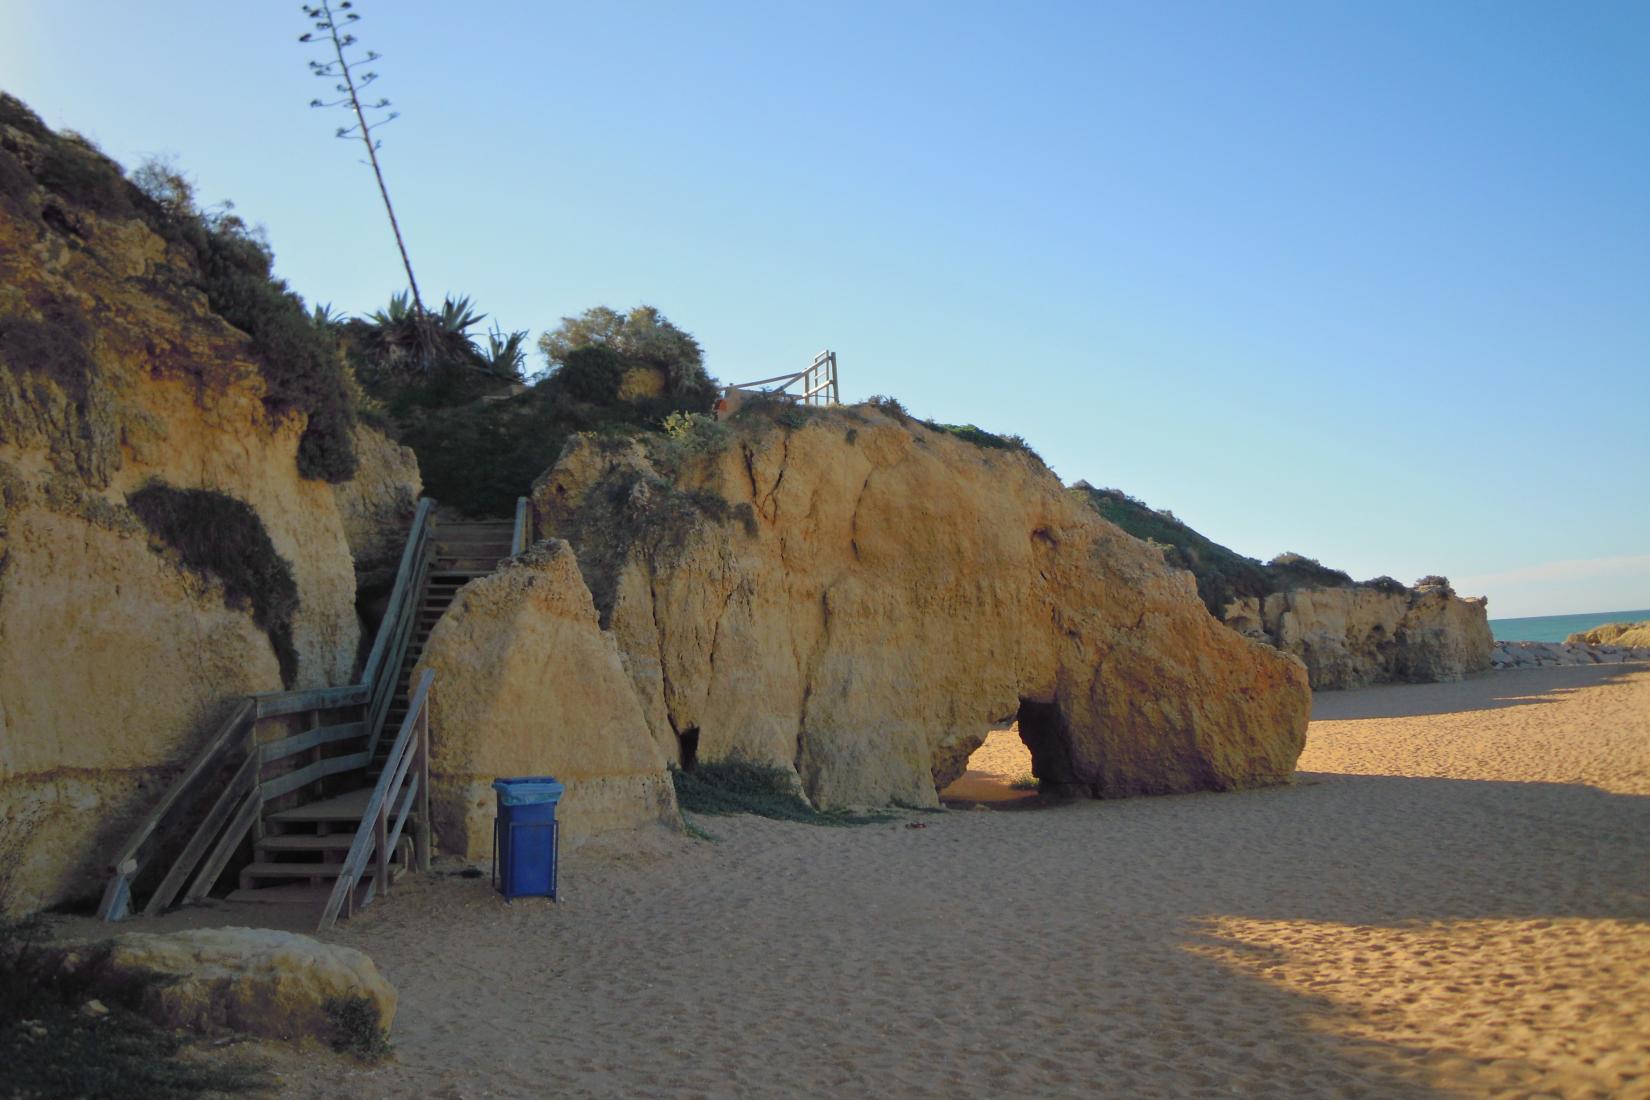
[{"xmin": 1071, "ymin": 482, "xmax": 1426, "ymax": 618}]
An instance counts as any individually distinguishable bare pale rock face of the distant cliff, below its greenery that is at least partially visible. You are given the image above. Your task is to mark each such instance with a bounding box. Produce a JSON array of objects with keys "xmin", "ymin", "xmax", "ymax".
[{"xmin": 1221, "ymin": 584, "xmax": 1493, "ymax": 691}]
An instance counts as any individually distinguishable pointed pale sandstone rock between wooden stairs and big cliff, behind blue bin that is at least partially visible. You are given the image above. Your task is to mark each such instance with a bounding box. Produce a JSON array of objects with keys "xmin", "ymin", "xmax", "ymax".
[{"xmin": 414, "ymin": 543, "xmax": 680, "ymax": 861}]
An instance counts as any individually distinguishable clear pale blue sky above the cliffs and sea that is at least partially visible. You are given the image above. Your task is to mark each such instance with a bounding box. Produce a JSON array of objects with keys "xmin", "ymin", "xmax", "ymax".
[{"xmin": 0, "ymin": 0, "xmax": 1650, "ymax": 618}]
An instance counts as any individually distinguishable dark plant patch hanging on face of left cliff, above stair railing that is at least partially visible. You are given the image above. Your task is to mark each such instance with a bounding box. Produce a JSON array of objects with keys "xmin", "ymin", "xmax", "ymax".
[{"xmin": 127, "ymin": 482, "xmax": 299, "ymax": 688}]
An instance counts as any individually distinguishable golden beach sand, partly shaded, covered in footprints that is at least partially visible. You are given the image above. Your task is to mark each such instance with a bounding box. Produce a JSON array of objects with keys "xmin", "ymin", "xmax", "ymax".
[{"xmin": 202, "ymin": 666, "xmax": 1650, "ymax": 1097}]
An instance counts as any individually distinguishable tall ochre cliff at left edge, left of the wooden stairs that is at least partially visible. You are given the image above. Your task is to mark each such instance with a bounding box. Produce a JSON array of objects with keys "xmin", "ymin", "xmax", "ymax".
[{"xmin": 0, "ymin": 99, "xmax": 412, "ymax": 907}]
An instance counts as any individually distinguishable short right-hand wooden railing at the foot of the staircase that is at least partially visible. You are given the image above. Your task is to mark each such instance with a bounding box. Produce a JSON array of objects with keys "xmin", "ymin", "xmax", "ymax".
[{"xmin": 318, "ymin": 668, "xmax": 436, "ymax": 932}]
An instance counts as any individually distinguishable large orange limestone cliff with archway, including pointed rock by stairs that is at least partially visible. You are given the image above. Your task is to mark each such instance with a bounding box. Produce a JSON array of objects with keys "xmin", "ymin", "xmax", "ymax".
[{"xmin": 427, "ymin": 407, "xmax": 1310, "ymax": 817}]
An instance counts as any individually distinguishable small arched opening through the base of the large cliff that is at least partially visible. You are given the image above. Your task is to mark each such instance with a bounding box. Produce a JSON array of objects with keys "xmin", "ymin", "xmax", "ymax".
[{"xmin": 939, "ymin": 699, "xmax": 1071, "ymax": 810}]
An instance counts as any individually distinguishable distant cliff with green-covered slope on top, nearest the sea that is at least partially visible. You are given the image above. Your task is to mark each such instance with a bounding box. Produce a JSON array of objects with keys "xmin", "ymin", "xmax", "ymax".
[{"xmin": 1073, "ymin": 482, "xmax": 1493, "ymax": 689}]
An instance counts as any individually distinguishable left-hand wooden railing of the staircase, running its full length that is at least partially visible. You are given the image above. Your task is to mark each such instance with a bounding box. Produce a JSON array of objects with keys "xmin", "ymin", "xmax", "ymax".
[{"xmin": 97, "ymin": 498, "xmax": 434, "ymax": 920}]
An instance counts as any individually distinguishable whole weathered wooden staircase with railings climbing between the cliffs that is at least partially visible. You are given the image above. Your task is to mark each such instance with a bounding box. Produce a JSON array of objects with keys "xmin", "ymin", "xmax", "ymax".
[{"xmin": 99, "ymin": 500, "xmax": 528, "ymax": 928}]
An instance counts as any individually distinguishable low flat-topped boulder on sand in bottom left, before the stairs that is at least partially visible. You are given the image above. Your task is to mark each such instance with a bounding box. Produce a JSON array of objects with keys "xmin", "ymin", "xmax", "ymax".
[{"xmin": 41, "ymin": 928, "xmax": 398, "ymax": 1041}]
